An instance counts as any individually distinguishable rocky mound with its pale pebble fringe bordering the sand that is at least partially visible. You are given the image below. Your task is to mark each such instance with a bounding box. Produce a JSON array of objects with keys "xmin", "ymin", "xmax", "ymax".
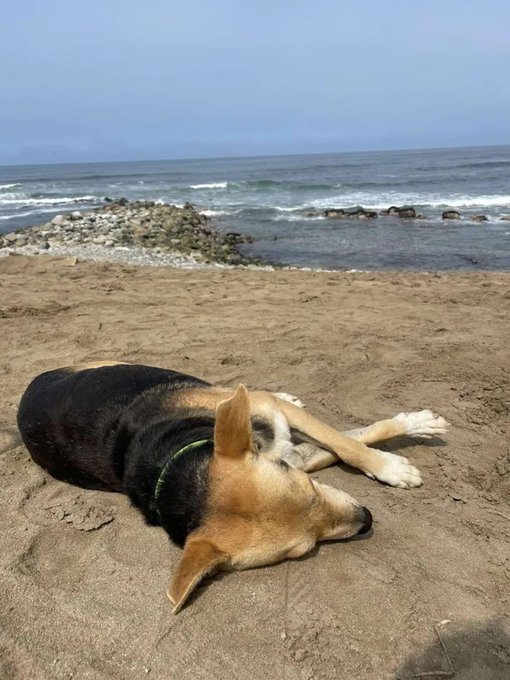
[{"xmin": 0, "ymin": 198, "xmax": 266, "ymax": 268}]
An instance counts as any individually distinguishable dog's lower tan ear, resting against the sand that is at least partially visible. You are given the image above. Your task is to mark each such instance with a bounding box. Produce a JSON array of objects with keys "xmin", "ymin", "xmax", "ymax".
[{"xmin": 166, "ymin": 539, "xmax": 230, "ymax": 614}]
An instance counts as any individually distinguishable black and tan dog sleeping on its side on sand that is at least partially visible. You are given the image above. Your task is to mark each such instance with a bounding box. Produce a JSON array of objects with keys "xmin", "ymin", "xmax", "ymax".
[{"xmin": 18, "ymin": 361, "xmax": 447, "ymax": 613}]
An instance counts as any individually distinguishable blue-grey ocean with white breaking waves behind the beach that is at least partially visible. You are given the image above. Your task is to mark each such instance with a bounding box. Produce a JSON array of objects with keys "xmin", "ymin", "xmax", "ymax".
[{"xmin": 0, "ymin": 146, "xmax": 510, "ymax": 270}]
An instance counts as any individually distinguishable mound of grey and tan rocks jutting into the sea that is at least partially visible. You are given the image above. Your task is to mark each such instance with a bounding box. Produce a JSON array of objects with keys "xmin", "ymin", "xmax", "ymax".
[{"xmin": 0, "ymin": 198, "xmax": 253, "ymax": 265}]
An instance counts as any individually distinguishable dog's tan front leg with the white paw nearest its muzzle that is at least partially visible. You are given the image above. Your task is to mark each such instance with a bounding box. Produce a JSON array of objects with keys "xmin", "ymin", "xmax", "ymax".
[{"xmin": 250, "ymin": 392, "xmax": 422, "ymax": 489}]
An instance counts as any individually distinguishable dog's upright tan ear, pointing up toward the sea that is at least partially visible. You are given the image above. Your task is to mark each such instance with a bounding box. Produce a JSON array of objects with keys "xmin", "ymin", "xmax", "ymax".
[{"xmin": 214, "ymin": 385, "xmax": 253, "ymax": 458}]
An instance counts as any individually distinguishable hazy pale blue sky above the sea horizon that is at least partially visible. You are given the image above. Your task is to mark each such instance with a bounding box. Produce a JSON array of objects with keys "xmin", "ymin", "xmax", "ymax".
[{"xmin": 0, "ymin": 0, "xmax": 510, "ymax": 164}]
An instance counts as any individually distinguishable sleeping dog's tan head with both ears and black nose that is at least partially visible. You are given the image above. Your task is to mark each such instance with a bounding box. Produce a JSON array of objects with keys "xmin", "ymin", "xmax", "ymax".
[{"xmin": 168, "ymin": 385, "xmax": 371, "ymax": 613}]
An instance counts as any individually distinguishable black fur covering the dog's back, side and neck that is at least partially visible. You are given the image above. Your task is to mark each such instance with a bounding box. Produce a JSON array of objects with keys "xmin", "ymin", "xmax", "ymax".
[{"xmin": 18, "ymin": 364, "xmax": 273, "ymax": 546}]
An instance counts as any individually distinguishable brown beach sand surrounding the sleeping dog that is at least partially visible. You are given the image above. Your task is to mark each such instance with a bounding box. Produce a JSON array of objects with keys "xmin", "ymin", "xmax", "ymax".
[{"xmin": 0, "ymin": 256, "xmax": 510, "ymax": 680}]
